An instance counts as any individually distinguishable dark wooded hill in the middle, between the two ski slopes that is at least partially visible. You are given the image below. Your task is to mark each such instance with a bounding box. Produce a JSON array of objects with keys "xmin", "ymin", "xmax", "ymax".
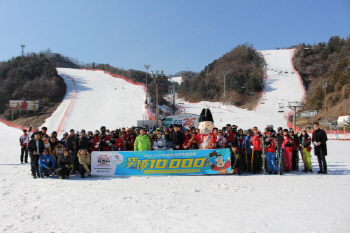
[{"xmin": 179, "ymin": 44, "xmax": 264, "ymax": 105}]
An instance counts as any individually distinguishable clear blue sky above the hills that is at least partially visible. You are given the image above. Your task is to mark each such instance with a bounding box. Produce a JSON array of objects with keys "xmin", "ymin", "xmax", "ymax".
[{"xmin": 0, "ymin": 0, "xmax": 350, "ymax": 74}]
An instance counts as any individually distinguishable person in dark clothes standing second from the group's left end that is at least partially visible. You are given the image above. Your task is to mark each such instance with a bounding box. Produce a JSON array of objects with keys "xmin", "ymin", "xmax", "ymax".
[{"xmin": 27, "ymin": 132, "xmax": 45, "ymax": 179}]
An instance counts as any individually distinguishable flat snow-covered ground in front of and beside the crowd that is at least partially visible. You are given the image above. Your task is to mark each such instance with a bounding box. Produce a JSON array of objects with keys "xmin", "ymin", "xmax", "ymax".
[{"xmin": 0, "ymin": 123, "xmax": 350, "ymax": 232}]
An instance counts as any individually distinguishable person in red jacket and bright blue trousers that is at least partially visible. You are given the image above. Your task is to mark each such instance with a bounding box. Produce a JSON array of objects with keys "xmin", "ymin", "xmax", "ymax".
[{"xmin": 264, "ymin": 131, "xmax": 278, "ymax": 174}]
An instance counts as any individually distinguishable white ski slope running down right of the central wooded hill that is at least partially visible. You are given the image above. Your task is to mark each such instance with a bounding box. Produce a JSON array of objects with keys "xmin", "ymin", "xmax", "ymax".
[{"xmin": 168, "ymin": 49, "xmax": 304, "ymax": 130}]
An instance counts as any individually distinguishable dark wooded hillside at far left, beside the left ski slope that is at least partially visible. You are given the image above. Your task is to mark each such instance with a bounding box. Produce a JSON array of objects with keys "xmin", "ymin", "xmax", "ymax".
[{"xmin": 0, "ymin": 53, "xmax": 66, "ymax": 119}]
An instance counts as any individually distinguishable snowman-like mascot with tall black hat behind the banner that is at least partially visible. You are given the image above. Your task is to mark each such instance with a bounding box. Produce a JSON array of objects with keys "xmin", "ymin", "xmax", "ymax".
[{"xmin": 196, "ymin": 108, "xmax": 216, "ymax": 150}]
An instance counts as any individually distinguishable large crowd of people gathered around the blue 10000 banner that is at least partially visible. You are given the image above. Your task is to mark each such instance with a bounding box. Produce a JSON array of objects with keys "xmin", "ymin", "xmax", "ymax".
[{"xmin": 19, "ymin": 122, "xmax": 327, "ymax": 179}]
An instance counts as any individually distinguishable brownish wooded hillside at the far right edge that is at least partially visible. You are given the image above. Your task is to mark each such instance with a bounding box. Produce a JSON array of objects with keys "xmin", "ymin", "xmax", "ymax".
[{"xmin": 293, "ymin": 36, "xmax": 350, "ymax": 110}]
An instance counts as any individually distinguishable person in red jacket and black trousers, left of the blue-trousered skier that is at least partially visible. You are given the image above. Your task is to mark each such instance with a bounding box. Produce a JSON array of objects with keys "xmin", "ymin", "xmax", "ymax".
[{"xmin": 250, "ymin": 127, "xmax": 262, "ymax": 174}]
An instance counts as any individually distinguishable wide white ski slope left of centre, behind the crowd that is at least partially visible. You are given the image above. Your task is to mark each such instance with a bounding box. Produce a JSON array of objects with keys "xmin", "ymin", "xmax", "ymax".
[{"xmin": 44, "ymin": 68, "xmax": 146, "ymax": 134}]
